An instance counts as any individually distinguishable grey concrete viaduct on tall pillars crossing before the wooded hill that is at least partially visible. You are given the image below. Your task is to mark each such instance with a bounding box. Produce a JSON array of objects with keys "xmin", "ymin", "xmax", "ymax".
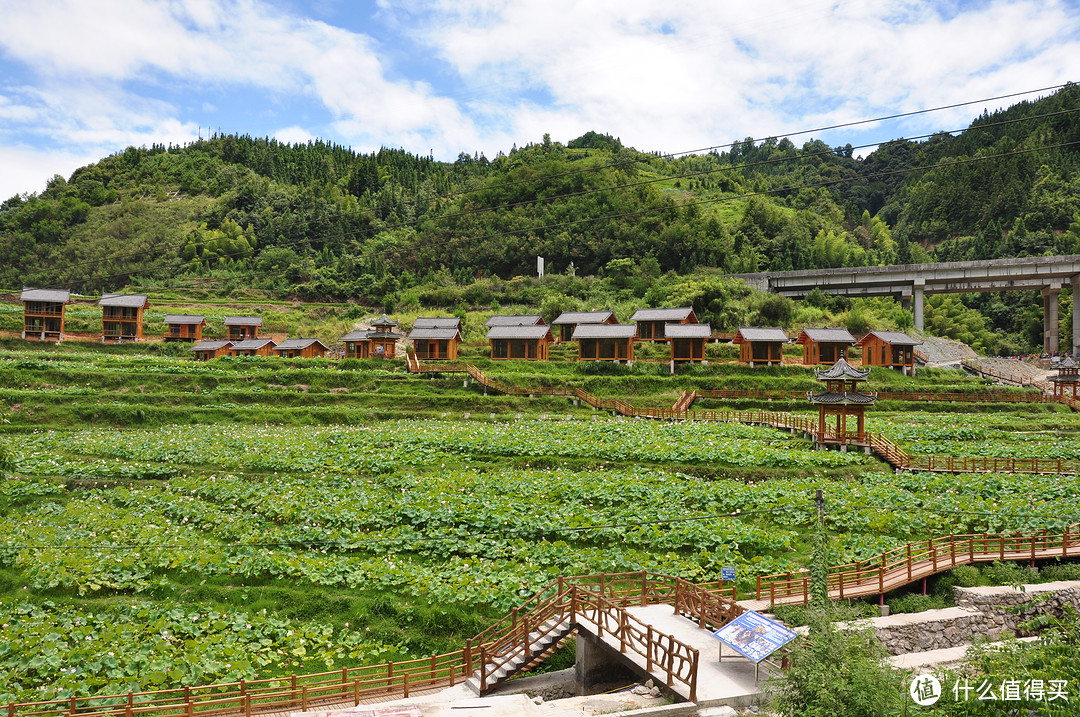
[{"xmin": 733, "ymin": 255, "xmax": 1080, "ymax": 355}]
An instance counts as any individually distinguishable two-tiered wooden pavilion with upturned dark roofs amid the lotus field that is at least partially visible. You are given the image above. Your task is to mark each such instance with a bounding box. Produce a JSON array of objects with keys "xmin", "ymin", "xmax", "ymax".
[{"xmin": 807, "ymin": 359, "xmax": 877, "ymax": 450}]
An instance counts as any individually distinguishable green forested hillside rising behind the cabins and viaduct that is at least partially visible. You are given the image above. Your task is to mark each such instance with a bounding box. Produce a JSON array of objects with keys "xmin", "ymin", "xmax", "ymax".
[{"xmin": 0, "ymin": 85, "xmax": 1080, "ymax": 352}]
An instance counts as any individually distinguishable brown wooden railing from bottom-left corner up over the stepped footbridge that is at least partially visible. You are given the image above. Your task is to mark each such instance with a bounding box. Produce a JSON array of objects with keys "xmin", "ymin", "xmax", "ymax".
[{"xmin": 6, "ymin": 571, "xmax": 743, "ymax": 717}]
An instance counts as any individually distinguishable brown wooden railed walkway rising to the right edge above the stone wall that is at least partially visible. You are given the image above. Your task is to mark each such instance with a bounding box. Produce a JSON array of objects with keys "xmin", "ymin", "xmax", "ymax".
[{"xmin": 756, "ymin": 523, "xmax": 1080, "ymax": 605}]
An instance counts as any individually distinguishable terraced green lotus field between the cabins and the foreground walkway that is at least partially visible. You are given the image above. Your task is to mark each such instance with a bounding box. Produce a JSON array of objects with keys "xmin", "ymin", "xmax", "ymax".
[{"xmin": 0, "ymin": 345, "xmax": 1080, "ymax": 702}]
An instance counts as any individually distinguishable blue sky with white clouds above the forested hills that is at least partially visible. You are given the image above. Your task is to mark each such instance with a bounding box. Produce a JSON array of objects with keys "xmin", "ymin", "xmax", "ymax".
[{"xmin": 0, "ymin": 0, "xmax": 1080, "ymax": 199}]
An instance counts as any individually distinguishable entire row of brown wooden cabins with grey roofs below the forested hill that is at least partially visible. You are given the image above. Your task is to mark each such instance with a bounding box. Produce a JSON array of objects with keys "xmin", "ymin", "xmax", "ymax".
[{"xmin": 22, "ymin": 288, "xmax": 920, "ymax": 373}]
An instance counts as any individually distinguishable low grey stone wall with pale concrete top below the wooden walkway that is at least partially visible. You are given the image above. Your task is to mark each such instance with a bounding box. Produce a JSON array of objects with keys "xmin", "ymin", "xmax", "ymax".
[{"xmin": 840, "ymin": 581, "xmax": 1080, "ymax": 654}]
